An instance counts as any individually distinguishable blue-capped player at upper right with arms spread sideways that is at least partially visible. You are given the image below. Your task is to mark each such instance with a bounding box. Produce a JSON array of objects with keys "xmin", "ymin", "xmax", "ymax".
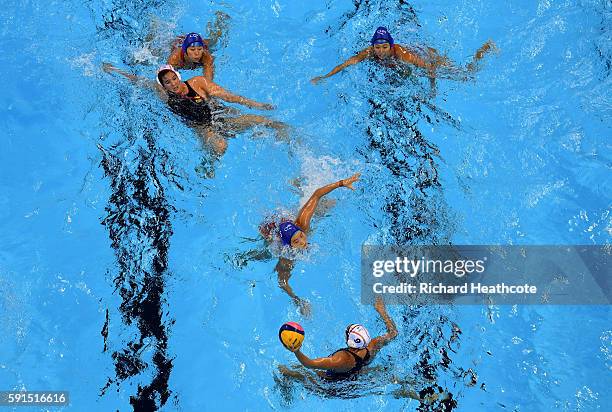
[{"xmin": 311, "ymin": 27, "xmax": 496, "ymax": 90}]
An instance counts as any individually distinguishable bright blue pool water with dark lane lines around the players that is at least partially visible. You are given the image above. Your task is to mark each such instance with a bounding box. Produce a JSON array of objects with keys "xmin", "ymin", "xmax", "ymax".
[{"xmin": 0, "ymin": 0, "xmax": 612, "ymax": 411}]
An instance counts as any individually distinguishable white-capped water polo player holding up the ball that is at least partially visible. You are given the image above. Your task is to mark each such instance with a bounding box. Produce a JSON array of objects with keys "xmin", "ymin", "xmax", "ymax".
[{"xmin": 279, "ymin": 297, "xmax": 397, "ymax": 382}]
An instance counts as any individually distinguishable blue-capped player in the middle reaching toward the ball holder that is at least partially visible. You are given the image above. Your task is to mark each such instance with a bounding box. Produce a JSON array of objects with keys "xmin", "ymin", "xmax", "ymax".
[{"xmin": 259, "ymin": 173, "xmax": 361, "ymax": 316}]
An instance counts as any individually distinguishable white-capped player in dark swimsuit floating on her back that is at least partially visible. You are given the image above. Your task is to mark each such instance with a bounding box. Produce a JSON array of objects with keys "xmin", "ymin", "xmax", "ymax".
[{"xmin": 102, "ymin": 63, "xmax": 287, "ymax": 156}]
